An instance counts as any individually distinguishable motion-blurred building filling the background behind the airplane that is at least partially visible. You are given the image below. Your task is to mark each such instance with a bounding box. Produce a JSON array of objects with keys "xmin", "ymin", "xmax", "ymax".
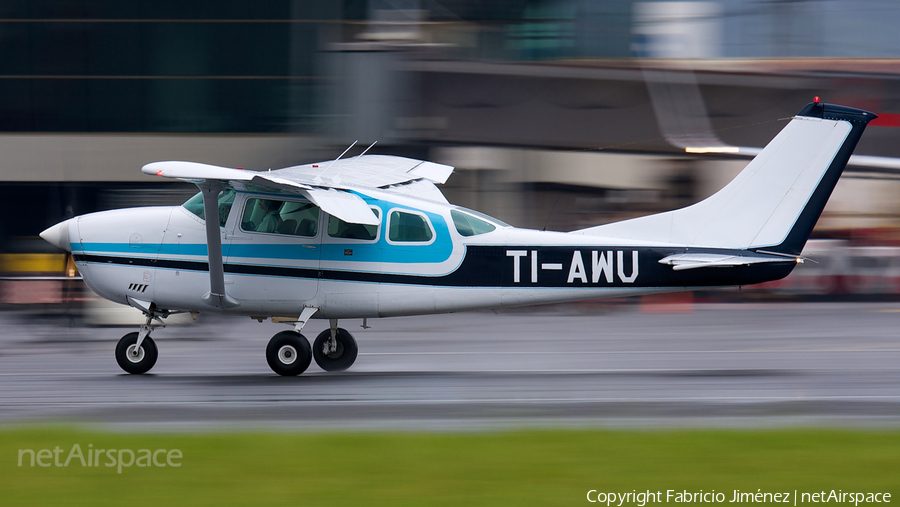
[{"xmin": 0, "ymin": 0, "xmax": 900, "ymax": 302}]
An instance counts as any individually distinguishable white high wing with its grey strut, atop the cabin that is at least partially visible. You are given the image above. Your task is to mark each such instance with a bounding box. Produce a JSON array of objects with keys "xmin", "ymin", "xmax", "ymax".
[{"xmin": 141, "ymin": 155, "xmax": 453, "ymax": 308}]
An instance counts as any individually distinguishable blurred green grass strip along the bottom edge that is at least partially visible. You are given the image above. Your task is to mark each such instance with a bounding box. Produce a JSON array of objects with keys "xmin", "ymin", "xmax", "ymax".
[{"xmin": 0, "ymin": 427, "xmax": 900, "ymax": 507}]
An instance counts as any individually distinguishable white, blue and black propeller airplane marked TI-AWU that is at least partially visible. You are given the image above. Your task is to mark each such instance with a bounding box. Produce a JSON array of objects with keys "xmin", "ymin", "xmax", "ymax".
[{"xmin": 41, "ymin": 97, "xmax": 877, "ymax": 376}]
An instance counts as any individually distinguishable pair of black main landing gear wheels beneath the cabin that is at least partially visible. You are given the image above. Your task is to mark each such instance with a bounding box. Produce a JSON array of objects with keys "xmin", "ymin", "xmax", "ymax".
[{"xmin": 266, "ymin": 319, "xmax": 359, "ymax": 376}]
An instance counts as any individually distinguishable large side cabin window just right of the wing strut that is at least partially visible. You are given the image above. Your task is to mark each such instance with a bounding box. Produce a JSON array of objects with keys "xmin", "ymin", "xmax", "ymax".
[{"xmin": 241, "ymin": 198, "xmax": 319, "ymax": 238}]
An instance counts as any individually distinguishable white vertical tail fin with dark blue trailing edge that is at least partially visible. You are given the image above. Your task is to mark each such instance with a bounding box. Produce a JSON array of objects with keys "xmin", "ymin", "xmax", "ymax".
[{"xmin": 573, "ymin": 100, "xmax": 877, "ymax": 255}]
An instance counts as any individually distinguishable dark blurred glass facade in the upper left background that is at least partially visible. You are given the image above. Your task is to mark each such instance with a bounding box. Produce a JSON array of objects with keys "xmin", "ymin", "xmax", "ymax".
[{"xmin": 0, "ymin": 0, "xmax": 342, "ymax": 132}]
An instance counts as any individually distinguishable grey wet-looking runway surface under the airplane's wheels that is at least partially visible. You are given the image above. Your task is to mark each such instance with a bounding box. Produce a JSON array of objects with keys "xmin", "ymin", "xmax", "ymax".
[{"xmin": 0, "ymin": 303, "xmax": 900, "ymax": 430}]
